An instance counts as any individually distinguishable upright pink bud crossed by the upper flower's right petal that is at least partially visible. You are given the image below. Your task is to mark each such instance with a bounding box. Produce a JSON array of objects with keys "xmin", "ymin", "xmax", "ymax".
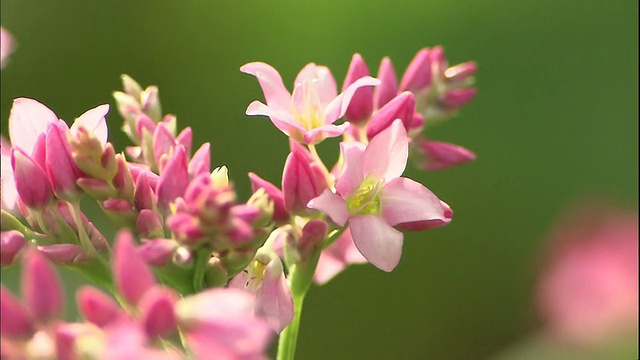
[{"xmin": 342, "ymin": 54, "xmax": 373, "ymax": 123}]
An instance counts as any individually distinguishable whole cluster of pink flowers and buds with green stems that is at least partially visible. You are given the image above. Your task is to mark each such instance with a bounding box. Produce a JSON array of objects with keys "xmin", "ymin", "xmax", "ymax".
[{"xmin": 1, "ymin": 47, "xmax": 476, "ymax": 359}]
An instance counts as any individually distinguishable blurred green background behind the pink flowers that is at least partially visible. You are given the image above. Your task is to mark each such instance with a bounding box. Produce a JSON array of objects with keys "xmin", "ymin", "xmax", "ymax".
[{"xmin": 0, "ymin": 0, "xmax": 638, "ymax": 359}]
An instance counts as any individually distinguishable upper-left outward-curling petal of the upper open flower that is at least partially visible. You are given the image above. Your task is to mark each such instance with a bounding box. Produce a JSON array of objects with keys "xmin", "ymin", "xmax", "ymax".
[{"xmin": 240, "ymin": 62, "xmax": 291, "ymax": 109}]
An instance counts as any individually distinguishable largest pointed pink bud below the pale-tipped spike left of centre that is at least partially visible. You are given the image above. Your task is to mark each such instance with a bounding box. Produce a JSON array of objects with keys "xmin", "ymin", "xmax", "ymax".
[{"xmin": 156, "ymin": 145, "xmax": 189, "ymax": 211}]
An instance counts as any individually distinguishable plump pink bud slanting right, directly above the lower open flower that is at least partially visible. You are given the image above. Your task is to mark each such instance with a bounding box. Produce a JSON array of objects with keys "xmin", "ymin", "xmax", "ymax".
[{"xmin": 366, "ymin": 91, "xmax": 416, "ymax": 139}]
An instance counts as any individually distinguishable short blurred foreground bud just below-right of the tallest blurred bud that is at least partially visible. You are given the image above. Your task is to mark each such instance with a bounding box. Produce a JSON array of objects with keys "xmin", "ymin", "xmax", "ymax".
[{"xmin": 139, "ymin": 286, "xmax": 177, "ymax": 338}]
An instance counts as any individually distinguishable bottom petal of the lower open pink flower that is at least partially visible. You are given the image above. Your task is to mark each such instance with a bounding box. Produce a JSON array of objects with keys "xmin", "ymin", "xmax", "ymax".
[{"xmin": 349, "ymin": 215, "xmax": 404, "ymax": 272}]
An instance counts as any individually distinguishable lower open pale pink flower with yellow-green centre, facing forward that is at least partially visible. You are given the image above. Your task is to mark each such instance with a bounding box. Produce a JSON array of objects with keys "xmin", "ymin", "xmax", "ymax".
[{"xmin": 308, "ymin": 120, "xmax": 451, "ymax": 271}]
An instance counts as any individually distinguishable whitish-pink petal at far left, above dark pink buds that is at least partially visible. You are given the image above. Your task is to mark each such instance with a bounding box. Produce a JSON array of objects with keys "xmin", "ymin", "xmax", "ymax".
[{"xmin": 9, "ymin": 98, "xmax": 58, "ymax": 155}]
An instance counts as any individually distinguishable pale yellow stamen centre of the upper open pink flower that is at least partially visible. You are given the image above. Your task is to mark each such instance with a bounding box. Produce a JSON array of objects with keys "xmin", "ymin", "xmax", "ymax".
[{"xmin": 292, "ymin": 79, "xmax": 324, "ymax": 130}]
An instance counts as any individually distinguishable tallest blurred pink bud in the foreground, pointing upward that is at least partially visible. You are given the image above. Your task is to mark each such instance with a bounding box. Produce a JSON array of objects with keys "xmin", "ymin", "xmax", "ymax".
[{"xmin": 113, "ymin": 230, "xmax": 155, "ymax": 305}]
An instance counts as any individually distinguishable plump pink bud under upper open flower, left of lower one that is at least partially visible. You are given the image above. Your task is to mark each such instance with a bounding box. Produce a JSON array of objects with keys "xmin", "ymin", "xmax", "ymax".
[{"xmin": 282, "ymin": 142, "xmax": 327, "ymax": 212}]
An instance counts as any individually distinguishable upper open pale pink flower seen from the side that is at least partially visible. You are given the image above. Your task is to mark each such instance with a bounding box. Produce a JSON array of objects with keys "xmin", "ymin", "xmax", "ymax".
[{"xmin": 240, "ymin": 62, "xmax": 379, "ymax": 144}]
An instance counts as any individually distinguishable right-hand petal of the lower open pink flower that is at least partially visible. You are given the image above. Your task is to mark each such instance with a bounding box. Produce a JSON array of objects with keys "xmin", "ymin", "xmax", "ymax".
[{"xmin": 380, "ymin": 177, "xmax": 445, "ymax": 226}]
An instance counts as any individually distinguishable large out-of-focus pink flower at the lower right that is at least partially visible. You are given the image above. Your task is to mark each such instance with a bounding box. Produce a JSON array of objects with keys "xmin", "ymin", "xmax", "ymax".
[{"xmin": 537, "ymin": 205, "xmax": 638, "ymax": 346}]
